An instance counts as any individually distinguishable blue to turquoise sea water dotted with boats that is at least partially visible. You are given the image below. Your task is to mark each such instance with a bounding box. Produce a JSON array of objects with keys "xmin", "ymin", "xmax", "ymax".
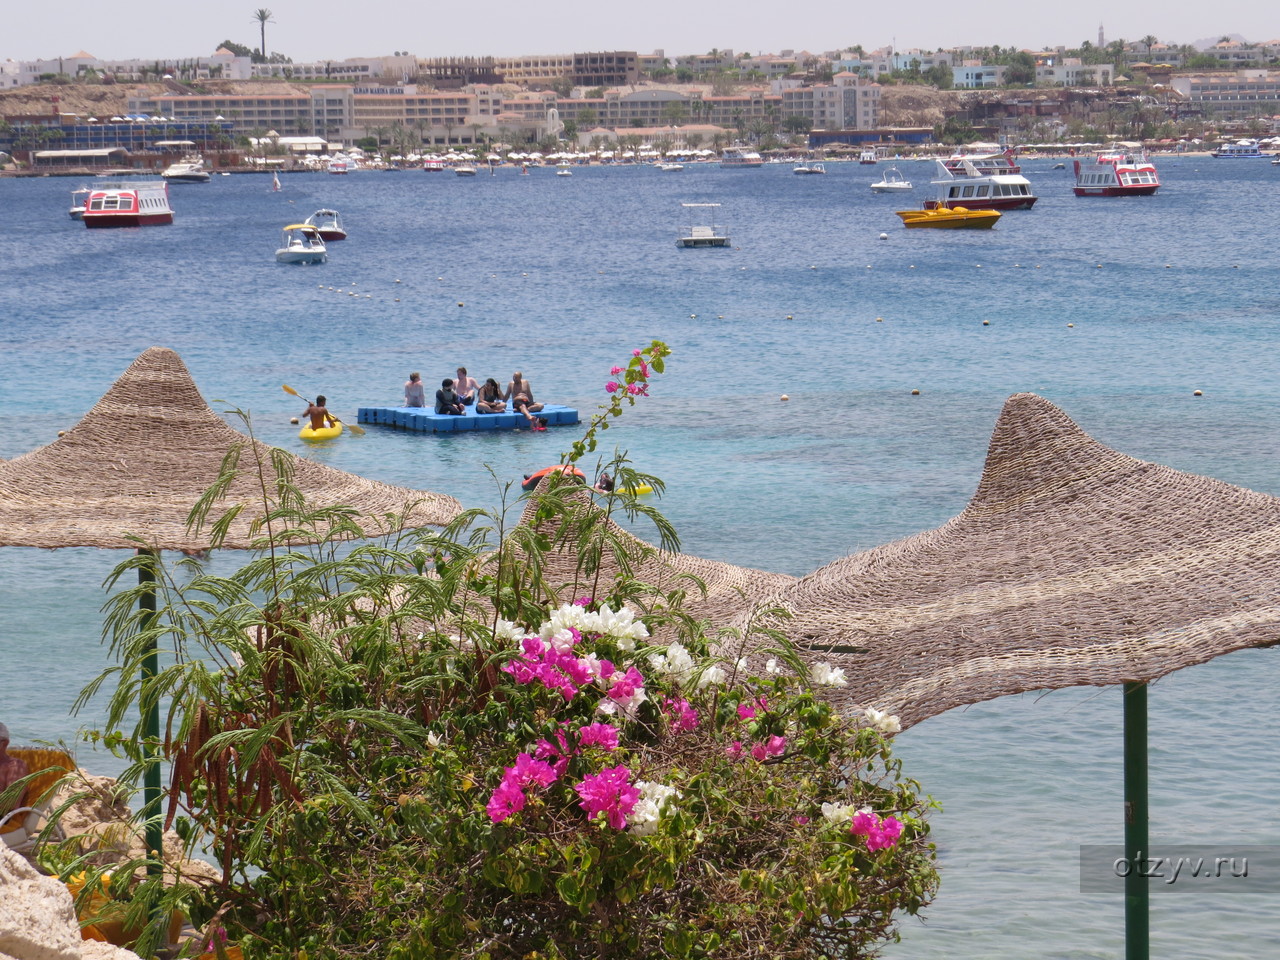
[{"xmin": 0, "ymin": 157, "xmax": 1280, "ymax": 960}]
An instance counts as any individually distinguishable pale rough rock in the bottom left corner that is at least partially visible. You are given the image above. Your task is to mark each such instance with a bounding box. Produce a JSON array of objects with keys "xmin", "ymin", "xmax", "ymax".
[{"xmin": 0, "ymin": 844, "xmax": 138, "ymax": 960}]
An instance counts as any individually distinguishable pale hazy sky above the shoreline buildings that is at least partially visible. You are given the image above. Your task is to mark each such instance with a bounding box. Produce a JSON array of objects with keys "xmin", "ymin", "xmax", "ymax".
[{"xmin": 0, "ymin": 0, "xmax": 1280, "ymax": 61}]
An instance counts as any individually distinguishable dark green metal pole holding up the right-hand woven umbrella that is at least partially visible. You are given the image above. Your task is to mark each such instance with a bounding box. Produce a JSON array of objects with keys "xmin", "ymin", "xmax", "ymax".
[{"xmin": 1124, "ymin": 682, "xmax": 1151, "ymax": 960}]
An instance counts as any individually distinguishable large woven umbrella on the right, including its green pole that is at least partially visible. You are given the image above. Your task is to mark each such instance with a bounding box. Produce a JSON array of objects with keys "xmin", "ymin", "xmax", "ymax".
[{"xmin": 747, "ymin": 393, "xmax": 1280, "ymax": 957}]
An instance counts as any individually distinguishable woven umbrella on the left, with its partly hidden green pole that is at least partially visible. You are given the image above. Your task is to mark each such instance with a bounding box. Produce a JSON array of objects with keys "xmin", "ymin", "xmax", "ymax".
[{"xmin": 0, "ymin": 347, "xmax": 461, "ymax": 870}]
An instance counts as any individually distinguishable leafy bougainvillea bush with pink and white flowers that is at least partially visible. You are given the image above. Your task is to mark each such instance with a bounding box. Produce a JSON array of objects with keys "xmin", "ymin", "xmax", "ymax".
[{"xmin": 85, "ymin": 343, "xmax": 937, "ymax": 960}]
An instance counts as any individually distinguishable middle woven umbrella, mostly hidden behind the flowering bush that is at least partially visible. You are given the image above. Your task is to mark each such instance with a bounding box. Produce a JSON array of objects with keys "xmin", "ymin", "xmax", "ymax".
[{"xmin": 520, "ymin": 489, "xmax": 795, "ymax": 625}]
